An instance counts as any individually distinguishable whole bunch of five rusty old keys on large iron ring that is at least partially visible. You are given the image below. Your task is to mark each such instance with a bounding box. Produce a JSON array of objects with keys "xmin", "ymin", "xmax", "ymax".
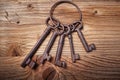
[{"xmin": 21, "ymin": 1, "xmax": 96, "ymax": 69}]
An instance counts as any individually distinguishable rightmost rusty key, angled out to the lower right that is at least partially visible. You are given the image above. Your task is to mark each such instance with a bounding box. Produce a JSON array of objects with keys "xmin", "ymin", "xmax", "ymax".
[{"xmin": 74, "ymin": 21, "xmax": 96, "ymax": 52}]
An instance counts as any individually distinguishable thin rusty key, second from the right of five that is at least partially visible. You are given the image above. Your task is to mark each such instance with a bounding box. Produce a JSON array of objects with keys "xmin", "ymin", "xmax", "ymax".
[{"xmin": 68, "ymin": 25, "xmax": 80, "ymax": 63}]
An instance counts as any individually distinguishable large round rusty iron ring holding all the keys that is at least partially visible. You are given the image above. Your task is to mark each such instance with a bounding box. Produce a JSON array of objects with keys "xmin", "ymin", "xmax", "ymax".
[{"xmin": 50, "ymin": 1, "xmax": 82, "ymax": 24}]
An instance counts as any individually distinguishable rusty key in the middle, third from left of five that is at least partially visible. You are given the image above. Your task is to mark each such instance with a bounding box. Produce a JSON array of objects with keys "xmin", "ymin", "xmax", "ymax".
[{"xmin": 55, "ymin": 26, "xmax": 70, "ymax": 68}]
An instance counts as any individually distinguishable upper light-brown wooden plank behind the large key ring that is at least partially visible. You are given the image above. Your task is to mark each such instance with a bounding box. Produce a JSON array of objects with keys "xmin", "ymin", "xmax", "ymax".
[{"xmin": 0, "ymin": 0, "xmax": 120, "ymax": 56}]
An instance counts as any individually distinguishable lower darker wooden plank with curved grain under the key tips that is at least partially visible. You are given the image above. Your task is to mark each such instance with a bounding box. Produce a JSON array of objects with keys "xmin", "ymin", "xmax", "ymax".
[{"xmin": 0, "ymin": 53, "xmax": 120, "ymax": 80}]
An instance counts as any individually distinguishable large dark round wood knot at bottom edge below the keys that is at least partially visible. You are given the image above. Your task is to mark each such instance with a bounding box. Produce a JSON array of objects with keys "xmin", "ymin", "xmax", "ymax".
[{"xmin": 42, "ymin": 67, "xmax": 57, "ymax": 80}]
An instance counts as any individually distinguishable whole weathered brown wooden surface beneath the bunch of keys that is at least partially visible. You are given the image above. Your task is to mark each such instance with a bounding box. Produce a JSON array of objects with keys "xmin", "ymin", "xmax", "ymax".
[{"xmin": 0, "ymin": 0, "xmax": 120, "ymax": 80}]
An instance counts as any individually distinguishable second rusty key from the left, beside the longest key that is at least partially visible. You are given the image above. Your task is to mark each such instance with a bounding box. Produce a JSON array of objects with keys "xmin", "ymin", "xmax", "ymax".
[{"xmin": 40, "ymin": 24, "xmax": 64, "ymax": 64}]
